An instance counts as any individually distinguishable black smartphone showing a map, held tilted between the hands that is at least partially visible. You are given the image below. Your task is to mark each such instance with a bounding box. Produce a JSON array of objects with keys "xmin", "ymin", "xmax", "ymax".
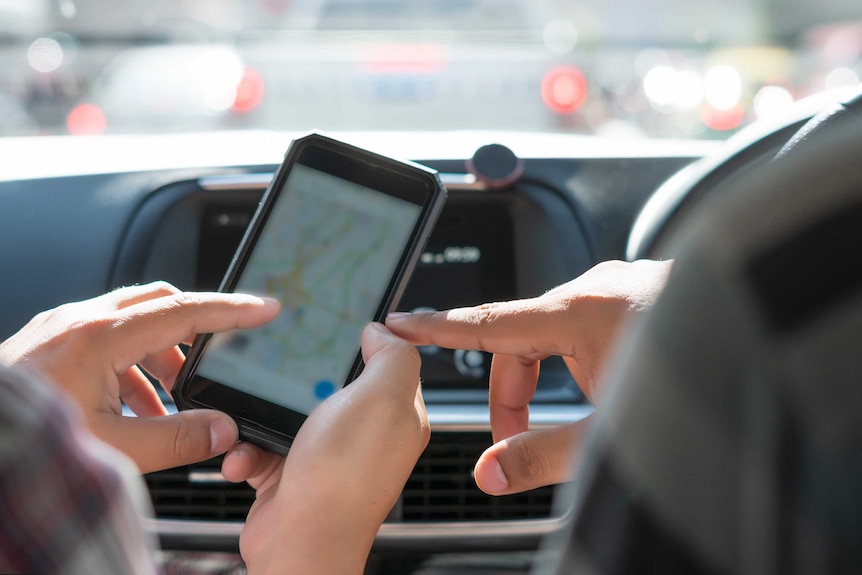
[{"xmin": 172, "ymin": 133, "xmax": 446, "ymax": 454}]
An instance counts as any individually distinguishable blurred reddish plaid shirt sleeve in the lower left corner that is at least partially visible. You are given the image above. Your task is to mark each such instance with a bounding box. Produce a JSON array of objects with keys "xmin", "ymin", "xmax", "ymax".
[{"xmin": 0, "ymin": 370, "xmax": 157, "ymax": 574}]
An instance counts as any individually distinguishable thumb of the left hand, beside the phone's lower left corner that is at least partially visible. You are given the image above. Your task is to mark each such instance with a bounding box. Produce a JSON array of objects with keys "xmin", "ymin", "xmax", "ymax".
[{"xmin": 90, "ymin": 409, "xmax": 238, "ymax": 473}]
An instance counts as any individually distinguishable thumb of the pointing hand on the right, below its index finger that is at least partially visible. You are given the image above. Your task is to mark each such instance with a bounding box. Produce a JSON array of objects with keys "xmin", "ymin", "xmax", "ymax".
[{"xmin": 473, "ymin": 420, "xmax": 587, "ymax": 495}]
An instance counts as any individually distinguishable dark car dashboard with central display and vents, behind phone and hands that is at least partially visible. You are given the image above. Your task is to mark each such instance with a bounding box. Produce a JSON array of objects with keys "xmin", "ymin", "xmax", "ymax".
[{"xmin": 0, "ymin": 132, "xmax": 719, "ymax": 573}]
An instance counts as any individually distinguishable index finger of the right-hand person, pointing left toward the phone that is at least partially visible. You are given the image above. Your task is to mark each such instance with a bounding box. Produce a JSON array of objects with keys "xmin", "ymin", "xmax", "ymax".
[{"xmin": 386, "ymin": 296, "xmax": 572, "ymax": 357}]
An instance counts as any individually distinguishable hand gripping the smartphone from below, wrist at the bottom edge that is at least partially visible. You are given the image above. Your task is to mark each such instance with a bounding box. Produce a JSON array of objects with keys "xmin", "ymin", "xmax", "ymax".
[{"xmin": 222, "ymin": 324, "xmax": 430, "ymax": 575}]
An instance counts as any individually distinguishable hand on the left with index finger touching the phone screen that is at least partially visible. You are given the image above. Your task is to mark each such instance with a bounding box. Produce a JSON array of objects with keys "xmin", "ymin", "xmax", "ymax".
[{"xmin": 0, "ymin": 282, "xmax": 279, "ymax": 472}]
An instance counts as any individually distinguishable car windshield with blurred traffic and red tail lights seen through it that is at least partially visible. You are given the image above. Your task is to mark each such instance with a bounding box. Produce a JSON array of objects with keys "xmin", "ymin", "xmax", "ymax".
[{"xmin": 0, "ymin": 0, "xmax": 862, "ymax": 139}]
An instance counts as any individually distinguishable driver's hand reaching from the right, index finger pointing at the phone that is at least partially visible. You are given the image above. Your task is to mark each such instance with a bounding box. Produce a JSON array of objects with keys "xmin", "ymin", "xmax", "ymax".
[{"xmin": 386, "ymin": 260, "xmax": 672, "ymax": 495}]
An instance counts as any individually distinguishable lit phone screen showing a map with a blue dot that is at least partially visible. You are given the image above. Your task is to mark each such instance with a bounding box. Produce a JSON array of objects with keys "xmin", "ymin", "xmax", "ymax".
[{"xmin": 197, "ymin": 163, "xmax": 422, "ymax": 414}]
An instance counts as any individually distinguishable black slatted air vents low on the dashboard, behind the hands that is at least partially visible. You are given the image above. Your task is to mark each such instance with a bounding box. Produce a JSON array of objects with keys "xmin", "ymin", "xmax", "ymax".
[{"xmin": 146, "ymin": 432, "xmax": 552, "ymax": 522}]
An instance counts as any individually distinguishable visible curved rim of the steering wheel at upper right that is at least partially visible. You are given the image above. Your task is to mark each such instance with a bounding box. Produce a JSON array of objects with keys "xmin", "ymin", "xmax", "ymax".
[{"xmin": 626, "ymin": 86, "xmax": 862, "ymax": 261}]
